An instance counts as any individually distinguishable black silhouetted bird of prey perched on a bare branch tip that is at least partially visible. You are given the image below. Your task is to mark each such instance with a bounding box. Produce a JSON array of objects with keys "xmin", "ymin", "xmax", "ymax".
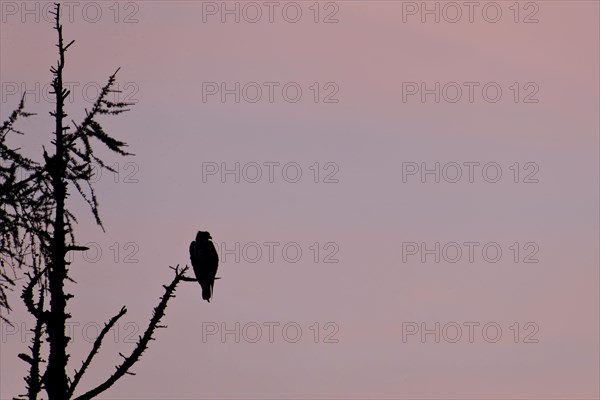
[{"xmin": 190, "ymin": 231, "xmax": 219, "ymax": 303}]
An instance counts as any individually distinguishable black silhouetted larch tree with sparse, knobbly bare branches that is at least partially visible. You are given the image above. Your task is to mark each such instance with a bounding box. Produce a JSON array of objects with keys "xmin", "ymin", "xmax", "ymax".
[{"xmin": 0, "ymin": 4, "xmax": 194, "ymax": 400}]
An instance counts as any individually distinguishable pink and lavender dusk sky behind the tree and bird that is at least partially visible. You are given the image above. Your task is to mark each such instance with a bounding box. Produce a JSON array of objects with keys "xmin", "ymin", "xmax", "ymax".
[{"xmin": 0, "ymin": 1, "xmax": 600, "ymax": 399}]
